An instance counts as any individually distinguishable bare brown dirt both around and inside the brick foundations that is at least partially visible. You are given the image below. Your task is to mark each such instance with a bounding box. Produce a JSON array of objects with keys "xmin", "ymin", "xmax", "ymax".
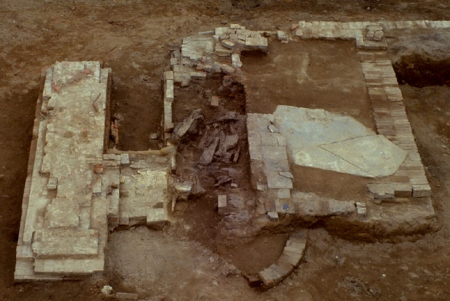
[{"xmin": 0, "ymin": 0, "xmax": 450, "ymax": 301}]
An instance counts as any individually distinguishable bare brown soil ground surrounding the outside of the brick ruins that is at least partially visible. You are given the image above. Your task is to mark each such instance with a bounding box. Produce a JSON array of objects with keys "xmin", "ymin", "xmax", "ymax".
[{"xmin": 0, "ymin": 0, "xmax": 450, "ymax": 300}]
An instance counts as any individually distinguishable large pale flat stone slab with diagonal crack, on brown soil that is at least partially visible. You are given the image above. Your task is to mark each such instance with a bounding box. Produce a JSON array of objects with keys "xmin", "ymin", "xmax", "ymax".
[{"xmin": 273, "ymin": 106, "xmax": 406, "ymax": 178}]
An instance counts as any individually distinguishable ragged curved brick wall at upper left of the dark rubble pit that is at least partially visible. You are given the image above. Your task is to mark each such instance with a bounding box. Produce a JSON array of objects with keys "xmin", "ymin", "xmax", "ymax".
[{"xmin": 163, "ymin": 24, "xmax": 268, "ymax": 143}]
